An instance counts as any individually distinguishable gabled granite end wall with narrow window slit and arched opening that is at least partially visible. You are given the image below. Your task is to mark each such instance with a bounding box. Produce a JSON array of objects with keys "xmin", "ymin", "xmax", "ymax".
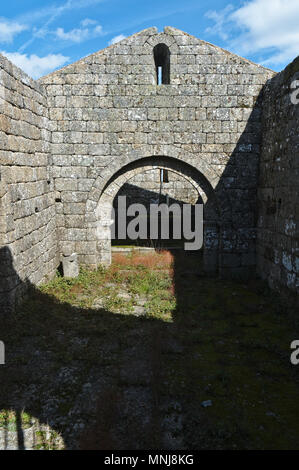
[{"xmin": 40, "ymin": 27, "xmax": 274, "ymax": 277}]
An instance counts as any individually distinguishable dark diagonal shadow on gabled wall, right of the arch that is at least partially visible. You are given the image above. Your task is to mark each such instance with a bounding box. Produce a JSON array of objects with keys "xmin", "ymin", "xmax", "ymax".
[{"xmin": 208, "ymin": 89, "xmax": 263, "ymax": 280}]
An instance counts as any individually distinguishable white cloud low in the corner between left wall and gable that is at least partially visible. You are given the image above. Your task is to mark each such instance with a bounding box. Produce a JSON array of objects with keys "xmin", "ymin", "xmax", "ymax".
[{"xmin": 1, "ymin": 51, "xmax": 69, "ymax": 79}]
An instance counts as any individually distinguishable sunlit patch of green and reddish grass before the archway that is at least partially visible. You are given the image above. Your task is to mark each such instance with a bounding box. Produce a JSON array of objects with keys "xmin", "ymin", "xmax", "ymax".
[{"xmin": 40, "ymin": 251, "xmax": 175, "ymax": 320}]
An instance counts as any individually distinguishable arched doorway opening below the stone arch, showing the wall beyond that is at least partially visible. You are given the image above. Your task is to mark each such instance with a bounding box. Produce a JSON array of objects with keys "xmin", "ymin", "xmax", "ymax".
[{"xmin": 112, "ymin": 165, "xmax": 203, "ymax": 253}]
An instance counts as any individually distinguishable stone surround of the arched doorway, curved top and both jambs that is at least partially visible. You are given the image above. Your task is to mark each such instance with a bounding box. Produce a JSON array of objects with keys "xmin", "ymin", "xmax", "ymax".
[{"xmin": 87, "ymin": 156, "xmax": 221, "ymax": 273}]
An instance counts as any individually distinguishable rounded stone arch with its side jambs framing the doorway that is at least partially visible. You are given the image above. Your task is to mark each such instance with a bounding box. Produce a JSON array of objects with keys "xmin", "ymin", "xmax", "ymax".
[{"xmin": 86, "ymin": 153, "xmax": 227, "ymax": 271}]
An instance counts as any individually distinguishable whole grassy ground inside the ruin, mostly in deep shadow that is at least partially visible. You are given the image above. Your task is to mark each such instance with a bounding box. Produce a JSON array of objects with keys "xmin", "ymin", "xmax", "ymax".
[{"xmin": 0, "ymin": 251, "xmax": 299, "ymax": 450}]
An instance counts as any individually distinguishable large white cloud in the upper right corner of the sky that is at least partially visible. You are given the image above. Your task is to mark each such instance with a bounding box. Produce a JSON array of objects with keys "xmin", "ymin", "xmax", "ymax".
[{"xmin": 206, "ymin": 0, "xmax": 299, "ymax": 64}]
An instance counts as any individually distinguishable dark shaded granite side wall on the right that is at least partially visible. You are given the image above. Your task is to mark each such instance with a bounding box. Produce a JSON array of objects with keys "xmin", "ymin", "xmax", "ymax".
[{"xmin": 257, "ymin": 57, "xmax": 299, "ymax": 302}]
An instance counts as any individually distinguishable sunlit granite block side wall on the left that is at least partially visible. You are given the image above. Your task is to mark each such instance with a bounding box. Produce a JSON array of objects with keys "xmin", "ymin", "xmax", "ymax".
[{"xmin": 0, "ymin": 56, "xmax": 58, "ymax": 313}]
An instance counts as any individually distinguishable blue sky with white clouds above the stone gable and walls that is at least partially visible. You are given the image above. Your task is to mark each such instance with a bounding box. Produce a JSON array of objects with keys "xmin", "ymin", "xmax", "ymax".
[{"xmin": 0, "ymin": 0, "xmax": 299, "ymax": 78}]
